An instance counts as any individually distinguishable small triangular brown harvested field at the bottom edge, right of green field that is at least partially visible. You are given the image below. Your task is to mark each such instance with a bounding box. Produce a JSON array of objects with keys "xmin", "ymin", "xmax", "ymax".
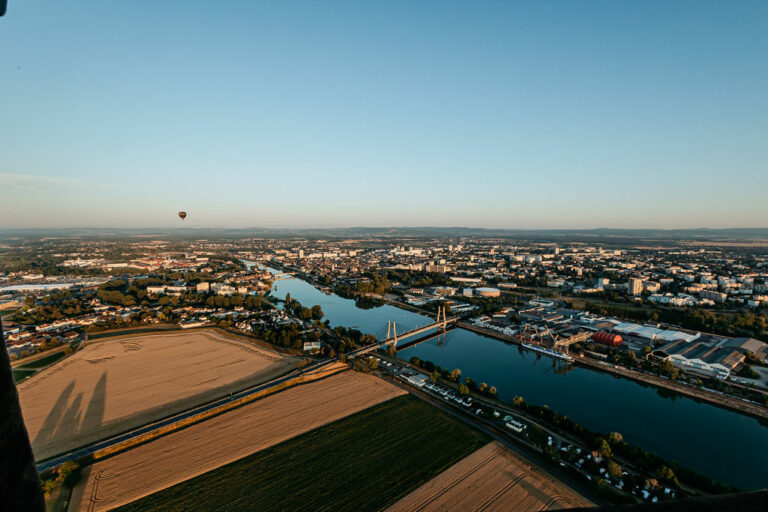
[{"xmin": 387, "ymin": 441, "xmax": 593, "ymax": 512}]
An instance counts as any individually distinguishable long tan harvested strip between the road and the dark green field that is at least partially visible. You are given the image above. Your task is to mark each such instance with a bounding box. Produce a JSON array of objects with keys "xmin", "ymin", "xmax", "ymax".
[{"xmin": 70, "ymin": 371, "xmax": 405, "ymax": 511}]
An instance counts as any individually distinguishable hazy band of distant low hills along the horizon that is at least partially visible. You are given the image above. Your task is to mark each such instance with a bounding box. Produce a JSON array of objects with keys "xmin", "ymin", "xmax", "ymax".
[{"xmin": 0, "ymin": 226, "xmax": 768, "ymax": 242}]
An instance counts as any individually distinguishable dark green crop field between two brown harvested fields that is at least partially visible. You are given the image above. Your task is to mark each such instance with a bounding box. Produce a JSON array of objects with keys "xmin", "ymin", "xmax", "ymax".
[{"xmin": 116, "ymin": 395, "xmax": 489, "ymax": 512}]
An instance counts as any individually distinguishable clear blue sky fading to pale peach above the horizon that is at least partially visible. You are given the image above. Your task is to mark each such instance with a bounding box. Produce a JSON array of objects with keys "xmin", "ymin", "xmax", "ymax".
[{"xmin": 0, "ymin": 0, "xmax": 768, "ymax": 228}]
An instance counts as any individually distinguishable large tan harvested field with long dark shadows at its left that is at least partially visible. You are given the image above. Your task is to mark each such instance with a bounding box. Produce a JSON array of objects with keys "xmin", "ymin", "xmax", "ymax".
[{"xmin": 18, "ymin": 330, "xmax": 296, "ymax": 460}]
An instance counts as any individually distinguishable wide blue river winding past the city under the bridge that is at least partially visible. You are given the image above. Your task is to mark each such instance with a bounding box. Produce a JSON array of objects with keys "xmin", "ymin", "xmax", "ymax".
[{"xmin": 264, "ymin": 266, "xmax": 768, "ymax": 489}]
